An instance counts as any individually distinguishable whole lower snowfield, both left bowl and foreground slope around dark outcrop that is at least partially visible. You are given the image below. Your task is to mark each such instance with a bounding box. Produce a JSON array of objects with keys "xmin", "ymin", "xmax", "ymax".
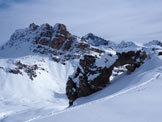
[{"xmin": 0, "ymin": 49, "xmax": 162, "ymax": 122}]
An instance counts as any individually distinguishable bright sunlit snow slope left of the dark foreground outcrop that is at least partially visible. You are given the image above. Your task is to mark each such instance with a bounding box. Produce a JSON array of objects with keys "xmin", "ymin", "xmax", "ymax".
[{"xmin": 0, "ymin": 55, "xmax": 74, "ymax": 122}]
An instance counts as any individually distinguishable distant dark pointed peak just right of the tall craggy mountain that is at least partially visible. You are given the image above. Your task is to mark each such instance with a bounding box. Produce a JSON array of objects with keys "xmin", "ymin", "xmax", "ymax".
[{"xmin": 81, "ymin": 33, "xmax": 115, "ymax": 47}]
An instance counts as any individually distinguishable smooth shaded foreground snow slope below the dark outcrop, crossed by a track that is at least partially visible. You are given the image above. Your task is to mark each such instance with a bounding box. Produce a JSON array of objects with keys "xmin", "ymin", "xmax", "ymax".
[{"xmin": 33, "ymin": 57, "xmax": 162, "ymax": 122}]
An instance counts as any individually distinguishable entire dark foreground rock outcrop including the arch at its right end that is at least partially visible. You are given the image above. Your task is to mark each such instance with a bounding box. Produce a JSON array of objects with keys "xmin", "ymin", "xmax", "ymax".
[{"xmin": 66, "ymin": 50, "xmax": 147, "ymax": 105}]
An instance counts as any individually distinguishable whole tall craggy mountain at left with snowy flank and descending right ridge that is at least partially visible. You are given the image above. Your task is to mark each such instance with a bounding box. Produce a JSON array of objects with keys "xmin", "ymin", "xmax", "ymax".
[{"xmin": 0, "ymin": 23, "xmax": 104, "ymax": 64}]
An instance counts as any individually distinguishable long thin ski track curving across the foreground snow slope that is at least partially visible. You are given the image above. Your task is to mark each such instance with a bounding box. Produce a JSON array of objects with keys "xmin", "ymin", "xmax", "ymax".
[{"xmin": 25, "ymin": 72, "xmax": 161, "ymax": 122}]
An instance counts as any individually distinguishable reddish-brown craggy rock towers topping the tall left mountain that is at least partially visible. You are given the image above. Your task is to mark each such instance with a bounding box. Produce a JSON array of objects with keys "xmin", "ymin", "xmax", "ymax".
[{"xmin": 34, "ymin": 24, "xmax": 72, "ymax": 50}]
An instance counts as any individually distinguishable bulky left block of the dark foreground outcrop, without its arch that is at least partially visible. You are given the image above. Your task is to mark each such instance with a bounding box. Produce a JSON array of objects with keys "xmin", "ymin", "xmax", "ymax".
[{"xmin": 66, "ymin": 55, "xmax": 111, "ymax": 105}]
